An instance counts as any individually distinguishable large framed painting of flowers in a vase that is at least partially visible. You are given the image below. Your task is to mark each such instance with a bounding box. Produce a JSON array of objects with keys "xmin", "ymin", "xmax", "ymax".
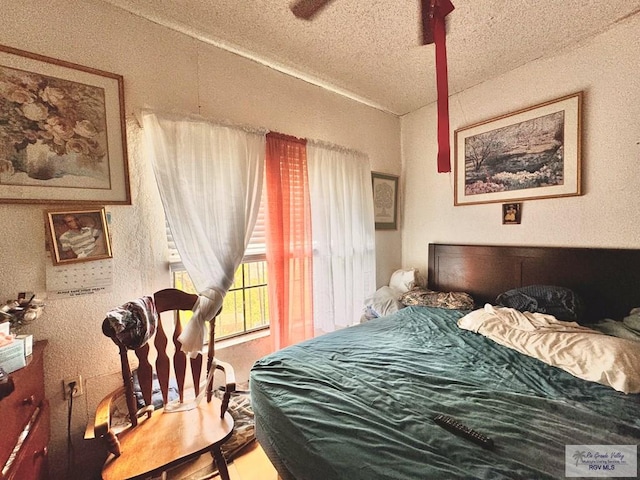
[{"xmin": 0, "ymin": 45, "xmax": 131, "ymax": 205}]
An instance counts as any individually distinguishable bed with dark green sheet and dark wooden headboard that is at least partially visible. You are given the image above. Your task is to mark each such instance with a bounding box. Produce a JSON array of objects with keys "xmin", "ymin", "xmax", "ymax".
[{"xmin": 250, "ymin": 244, "xmax": 640, "ymax": 480}]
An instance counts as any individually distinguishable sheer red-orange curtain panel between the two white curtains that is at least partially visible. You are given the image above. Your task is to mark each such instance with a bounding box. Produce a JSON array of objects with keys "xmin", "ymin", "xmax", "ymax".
[{"xmin": 266, "ymin": 133, "xmax": 313, "ymax": 350}]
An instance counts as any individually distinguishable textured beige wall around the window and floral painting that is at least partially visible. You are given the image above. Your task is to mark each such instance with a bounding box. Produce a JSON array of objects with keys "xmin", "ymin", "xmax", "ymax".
[{"xmin": 0, "ymin": 0, "xmax": 401, "ymax": 478}]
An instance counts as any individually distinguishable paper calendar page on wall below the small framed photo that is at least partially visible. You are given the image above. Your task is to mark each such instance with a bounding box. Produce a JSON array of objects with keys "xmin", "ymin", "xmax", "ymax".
[{"xmin": 46, "ymin": 259, "xmax": 113, "ymax": 298}]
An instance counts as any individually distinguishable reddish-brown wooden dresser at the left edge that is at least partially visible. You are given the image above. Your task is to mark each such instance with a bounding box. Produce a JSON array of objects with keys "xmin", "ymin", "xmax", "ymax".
[{"xmin": 0, "ymin": 341, "xmax": 50, "ymax": 480}]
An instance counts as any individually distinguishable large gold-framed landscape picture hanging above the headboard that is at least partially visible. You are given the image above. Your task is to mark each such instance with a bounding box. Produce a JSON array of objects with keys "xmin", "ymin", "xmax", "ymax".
[{"xmin": 454, "ymin": 92, "xmax": 582, "ymax": 205}]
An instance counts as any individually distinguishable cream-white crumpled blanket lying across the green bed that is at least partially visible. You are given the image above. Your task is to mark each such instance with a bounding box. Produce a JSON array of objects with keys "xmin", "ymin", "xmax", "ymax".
[{"xmin": 458, "ymin": 304, "xmax": 640, "ymax": 393}]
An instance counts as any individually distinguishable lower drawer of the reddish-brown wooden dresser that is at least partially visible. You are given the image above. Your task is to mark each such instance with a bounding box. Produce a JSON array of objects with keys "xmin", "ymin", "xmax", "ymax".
[{"xmin": 0, "ymin": 400, "xmax": 49, "ymax": 480}]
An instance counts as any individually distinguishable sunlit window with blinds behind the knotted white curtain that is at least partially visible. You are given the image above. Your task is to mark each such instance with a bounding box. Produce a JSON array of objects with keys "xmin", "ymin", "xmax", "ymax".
[{"xmin": 167, "ymin": 189, "xmax": 269, "ymax": 340}]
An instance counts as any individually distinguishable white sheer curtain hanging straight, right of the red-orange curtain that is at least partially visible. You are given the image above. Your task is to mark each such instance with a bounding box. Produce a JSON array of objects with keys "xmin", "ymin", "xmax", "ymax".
[{"xmin": 307, "ymin": 141, "xmax": 376, "ymax": 333}]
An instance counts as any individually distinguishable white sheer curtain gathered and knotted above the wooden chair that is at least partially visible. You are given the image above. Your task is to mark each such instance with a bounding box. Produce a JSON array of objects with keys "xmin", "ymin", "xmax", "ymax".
[{"xmin": 142, "ymin": 111, "xmax": 266, "ymax": 356}]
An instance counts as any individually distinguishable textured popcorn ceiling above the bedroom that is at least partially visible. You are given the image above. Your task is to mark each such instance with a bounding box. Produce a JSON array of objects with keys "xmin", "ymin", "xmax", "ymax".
[{"xmin": 103, "ymin": 0, "xmax": 640, "ymax": 115}]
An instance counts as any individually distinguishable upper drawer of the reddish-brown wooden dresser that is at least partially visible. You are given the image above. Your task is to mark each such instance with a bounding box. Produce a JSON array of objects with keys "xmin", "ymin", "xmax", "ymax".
[{"xmin": 0, "ymin": 342, "xmax": 46, "ymax": 468}]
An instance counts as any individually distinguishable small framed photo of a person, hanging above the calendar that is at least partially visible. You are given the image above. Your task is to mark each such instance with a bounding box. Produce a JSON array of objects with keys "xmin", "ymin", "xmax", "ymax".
[{"xmin": 46, "ymin": 207, "xmax": 112, "ymax": 265}]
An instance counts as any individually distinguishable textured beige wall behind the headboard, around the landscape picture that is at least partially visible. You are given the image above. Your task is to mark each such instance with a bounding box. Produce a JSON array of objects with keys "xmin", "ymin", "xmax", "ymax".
[{"xmin": 402, "ymin": 15, "xmax": 640, "ymax": 276}]
